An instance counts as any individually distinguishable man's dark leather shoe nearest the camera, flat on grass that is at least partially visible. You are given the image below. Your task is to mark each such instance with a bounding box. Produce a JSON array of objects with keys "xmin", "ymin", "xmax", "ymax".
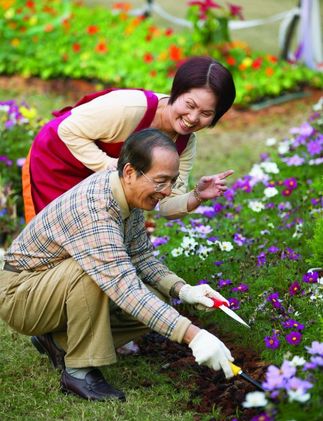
[{"xmin": 61, "ymin": 368, "xmax": 126, "ymax": 401}]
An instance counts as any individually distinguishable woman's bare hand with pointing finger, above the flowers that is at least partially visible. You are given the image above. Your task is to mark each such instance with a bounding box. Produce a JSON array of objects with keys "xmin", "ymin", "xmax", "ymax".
[{"xmin": 196, "ymin": 170, "xmax": 234, "ymax": 200}]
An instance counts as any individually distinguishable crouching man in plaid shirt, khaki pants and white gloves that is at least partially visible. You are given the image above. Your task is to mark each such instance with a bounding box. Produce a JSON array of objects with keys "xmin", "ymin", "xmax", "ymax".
[{"xmin": 0, "ymin": 129, "xmax": 233, "ymax": 400}]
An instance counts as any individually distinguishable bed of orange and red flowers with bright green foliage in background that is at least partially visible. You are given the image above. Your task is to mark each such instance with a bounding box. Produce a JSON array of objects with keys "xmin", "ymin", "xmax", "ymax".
[{"xmin": 0, "ymin": 0, "xmax": 323, "ymax": 107}]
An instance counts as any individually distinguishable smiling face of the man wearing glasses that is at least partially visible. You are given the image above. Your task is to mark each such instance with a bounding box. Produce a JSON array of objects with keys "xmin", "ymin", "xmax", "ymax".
[{"xmin": 127, "ymin": 148, "xmax": 179, "ymax": 210}]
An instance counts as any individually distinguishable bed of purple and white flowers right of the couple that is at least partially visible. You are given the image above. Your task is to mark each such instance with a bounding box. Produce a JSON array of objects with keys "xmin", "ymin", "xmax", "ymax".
[{"xmin": 150, "ymin": 100, "xmax": 323, "ymax": 421}]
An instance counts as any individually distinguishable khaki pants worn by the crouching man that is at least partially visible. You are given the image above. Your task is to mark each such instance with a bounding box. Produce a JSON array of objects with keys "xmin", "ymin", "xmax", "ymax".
[{"xmin": 0, "ymin": 258, "xmax": 166, "ymax": 368}]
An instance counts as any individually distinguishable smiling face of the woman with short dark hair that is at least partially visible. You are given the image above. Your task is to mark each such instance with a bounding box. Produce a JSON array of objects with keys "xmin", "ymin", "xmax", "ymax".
[{"xmin": 169, "ymin": 88, "xmax": 217, "ymax": 135}]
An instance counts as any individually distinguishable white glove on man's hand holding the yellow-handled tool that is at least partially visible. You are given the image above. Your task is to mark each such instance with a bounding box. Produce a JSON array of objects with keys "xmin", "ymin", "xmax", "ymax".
[{"xmin": 188, "ymin": 329, "xmax": 234, "ymax": 379}]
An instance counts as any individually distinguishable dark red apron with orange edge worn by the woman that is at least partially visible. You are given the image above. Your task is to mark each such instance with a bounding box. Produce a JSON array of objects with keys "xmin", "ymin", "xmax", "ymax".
[{"xmin": 22, "ymin": 89, "xmax": 189, "ymax": 223}]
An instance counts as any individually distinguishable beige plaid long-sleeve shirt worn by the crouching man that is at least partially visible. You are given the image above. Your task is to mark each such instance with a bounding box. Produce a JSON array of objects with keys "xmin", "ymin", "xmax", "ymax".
[{"xmin": 5, "ymin": 171, "xmax": 191, "ymax": 342}]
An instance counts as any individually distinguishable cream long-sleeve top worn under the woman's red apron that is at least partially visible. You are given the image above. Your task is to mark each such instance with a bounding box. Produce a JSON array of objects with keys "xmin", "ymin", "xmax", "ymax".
[{"xmin": 58, "ymin": 89, "xmax": 196, "ymax": 218}]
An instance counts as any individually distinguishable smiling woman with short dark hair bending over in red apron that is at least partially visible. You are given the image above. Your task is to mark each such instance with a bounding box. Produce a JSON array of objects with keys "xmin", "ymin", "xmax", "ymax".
[{"xmin": 23, "ymin": 57, "xmax": 235, "ymax": 222}]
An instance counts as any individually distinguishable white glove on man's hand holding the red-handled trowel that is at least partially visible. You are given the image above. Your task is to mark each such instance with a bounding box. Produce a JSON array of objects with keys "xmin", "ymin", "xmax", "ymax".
[{"xmin": 178, "ymin": 284, "xmax": 229, "ymax": 310}]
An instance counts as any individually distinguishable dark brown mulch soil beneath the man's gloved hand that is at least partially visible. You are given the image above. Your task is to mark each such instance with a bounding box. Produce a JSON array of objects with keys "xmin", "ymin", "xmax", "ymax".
[{"xmin": 139, "ymin": 317, "xmax": 269, "ymax": 421}]
